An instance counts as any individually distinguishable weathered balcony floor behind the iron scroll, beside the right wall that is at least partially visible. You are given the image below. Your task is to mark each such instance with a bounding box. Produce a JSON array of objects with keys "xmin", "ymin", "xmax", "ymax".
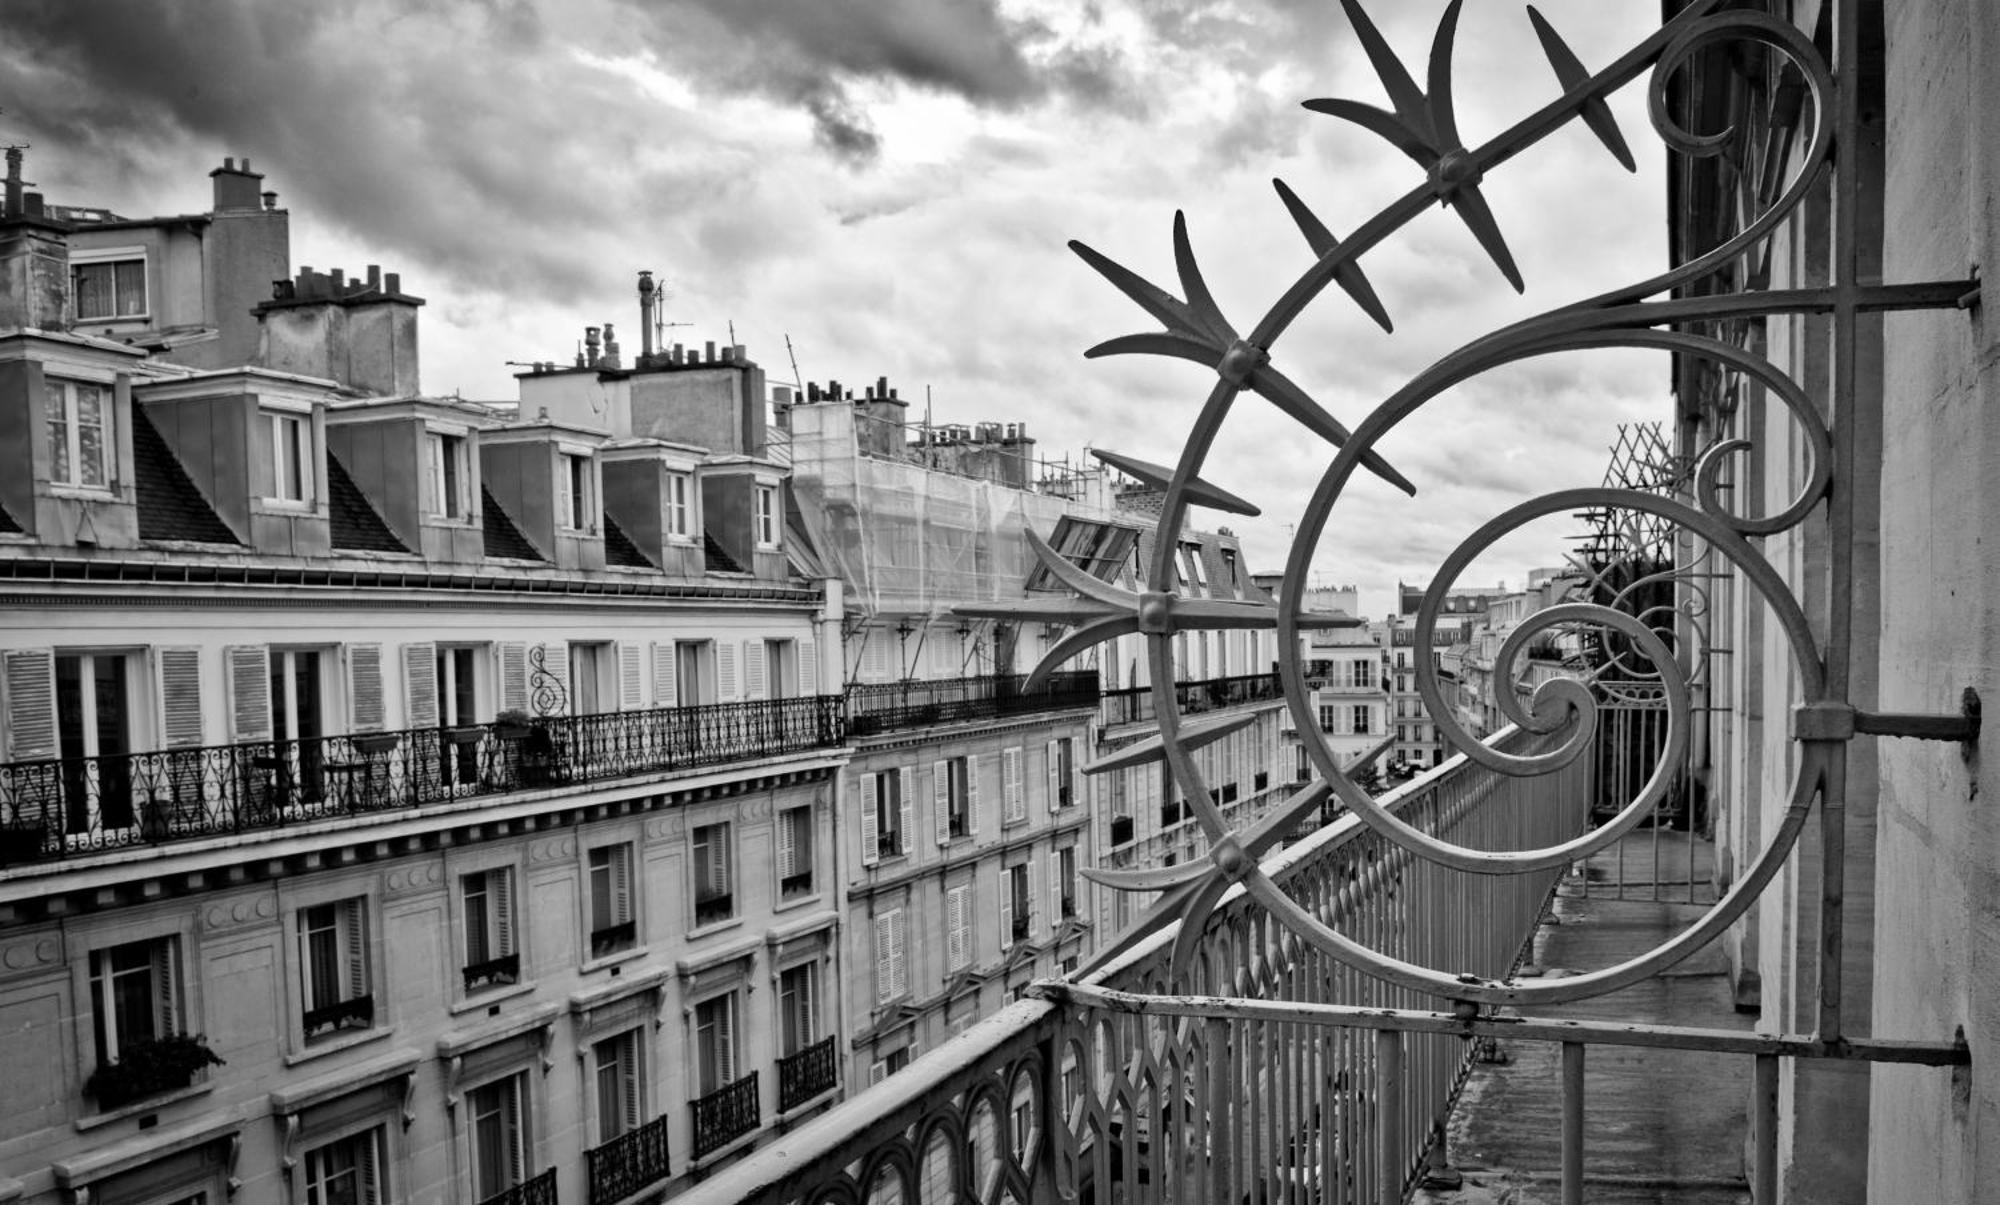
[{"xmin": 1414, "ymin": 831, "xmax": 1754, "ymax": 1205}]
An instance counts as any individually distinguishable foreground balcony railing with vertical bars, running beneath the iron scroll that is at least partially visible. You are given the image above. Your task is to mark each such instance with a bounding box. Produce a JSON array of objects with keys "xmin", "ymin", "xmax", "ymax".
[{"xmin": 686, "ymin": 720, "xmax": 1592, "ymax": 1205}]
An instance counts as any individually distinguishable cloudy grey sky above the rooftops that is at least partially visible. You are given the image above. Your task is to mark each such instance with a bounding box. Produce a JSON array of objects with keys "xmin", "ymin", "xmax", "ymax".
[{"xmin": 0, "ymin": 0, "xmax": 1668, "ymax": 615}]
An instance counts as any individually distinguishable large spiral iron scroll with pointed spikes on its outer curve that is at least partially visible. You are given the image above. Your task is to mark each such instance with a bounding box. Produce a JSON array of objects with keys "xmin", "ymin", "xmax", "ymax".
[{"xmin": 960, "ymin": 0, "xmax": 1976, "ymax": 1012}]
